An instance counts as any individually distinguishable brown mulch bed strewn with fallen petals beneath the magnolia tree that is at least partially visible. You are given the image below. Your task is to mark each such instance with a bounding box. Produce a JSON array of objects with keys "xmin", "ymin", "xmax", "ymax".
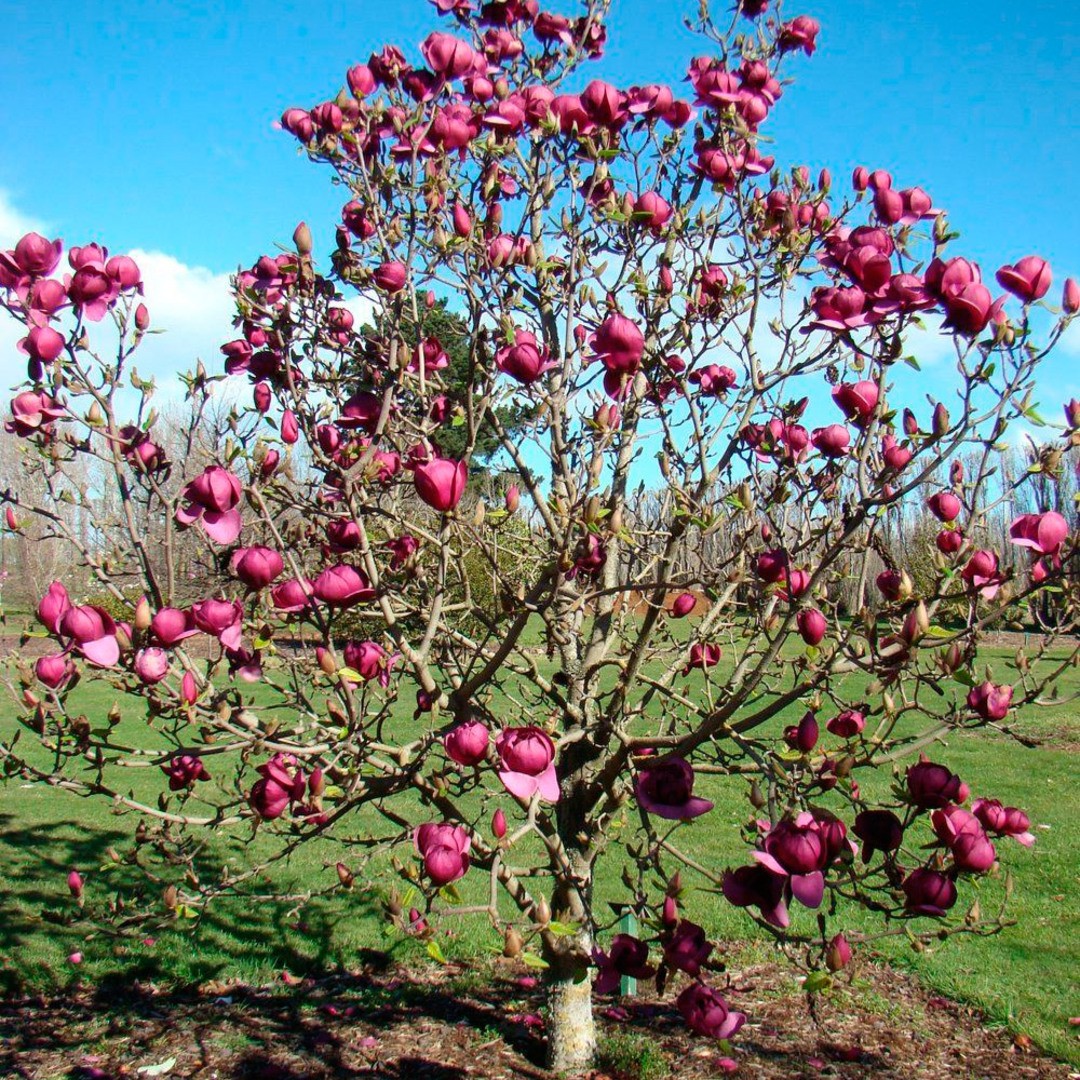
[{"xmin": 0, "ymin": 962, "xmax": 1077, "ymax": 1080}]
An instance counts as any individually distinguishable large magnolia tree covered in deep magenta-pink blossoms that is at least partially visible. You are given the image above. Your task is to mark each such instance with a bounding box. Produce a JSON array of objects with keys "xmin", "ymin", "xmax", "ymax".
[{"xmin": 0, "ymin": 0, "xmax": 1080, "ymax": 1071}]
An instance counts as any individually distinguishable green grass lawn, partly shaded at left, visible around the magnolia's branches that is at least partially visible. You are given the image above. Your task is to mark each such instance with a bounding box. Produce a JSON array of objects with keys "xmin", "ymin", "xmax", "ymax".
[{"xmin": 0, "ymin": 651, "xmax": 1080, "ymax": 1064}]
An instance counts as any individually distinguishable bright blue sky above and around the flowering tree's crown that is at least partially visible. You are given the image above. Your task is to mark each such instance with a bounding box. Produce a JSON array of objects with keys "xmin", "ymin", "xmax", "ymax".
[{"xmin": 0, "ymin": 0, "xmax": 1080, "ymax": 397}]
